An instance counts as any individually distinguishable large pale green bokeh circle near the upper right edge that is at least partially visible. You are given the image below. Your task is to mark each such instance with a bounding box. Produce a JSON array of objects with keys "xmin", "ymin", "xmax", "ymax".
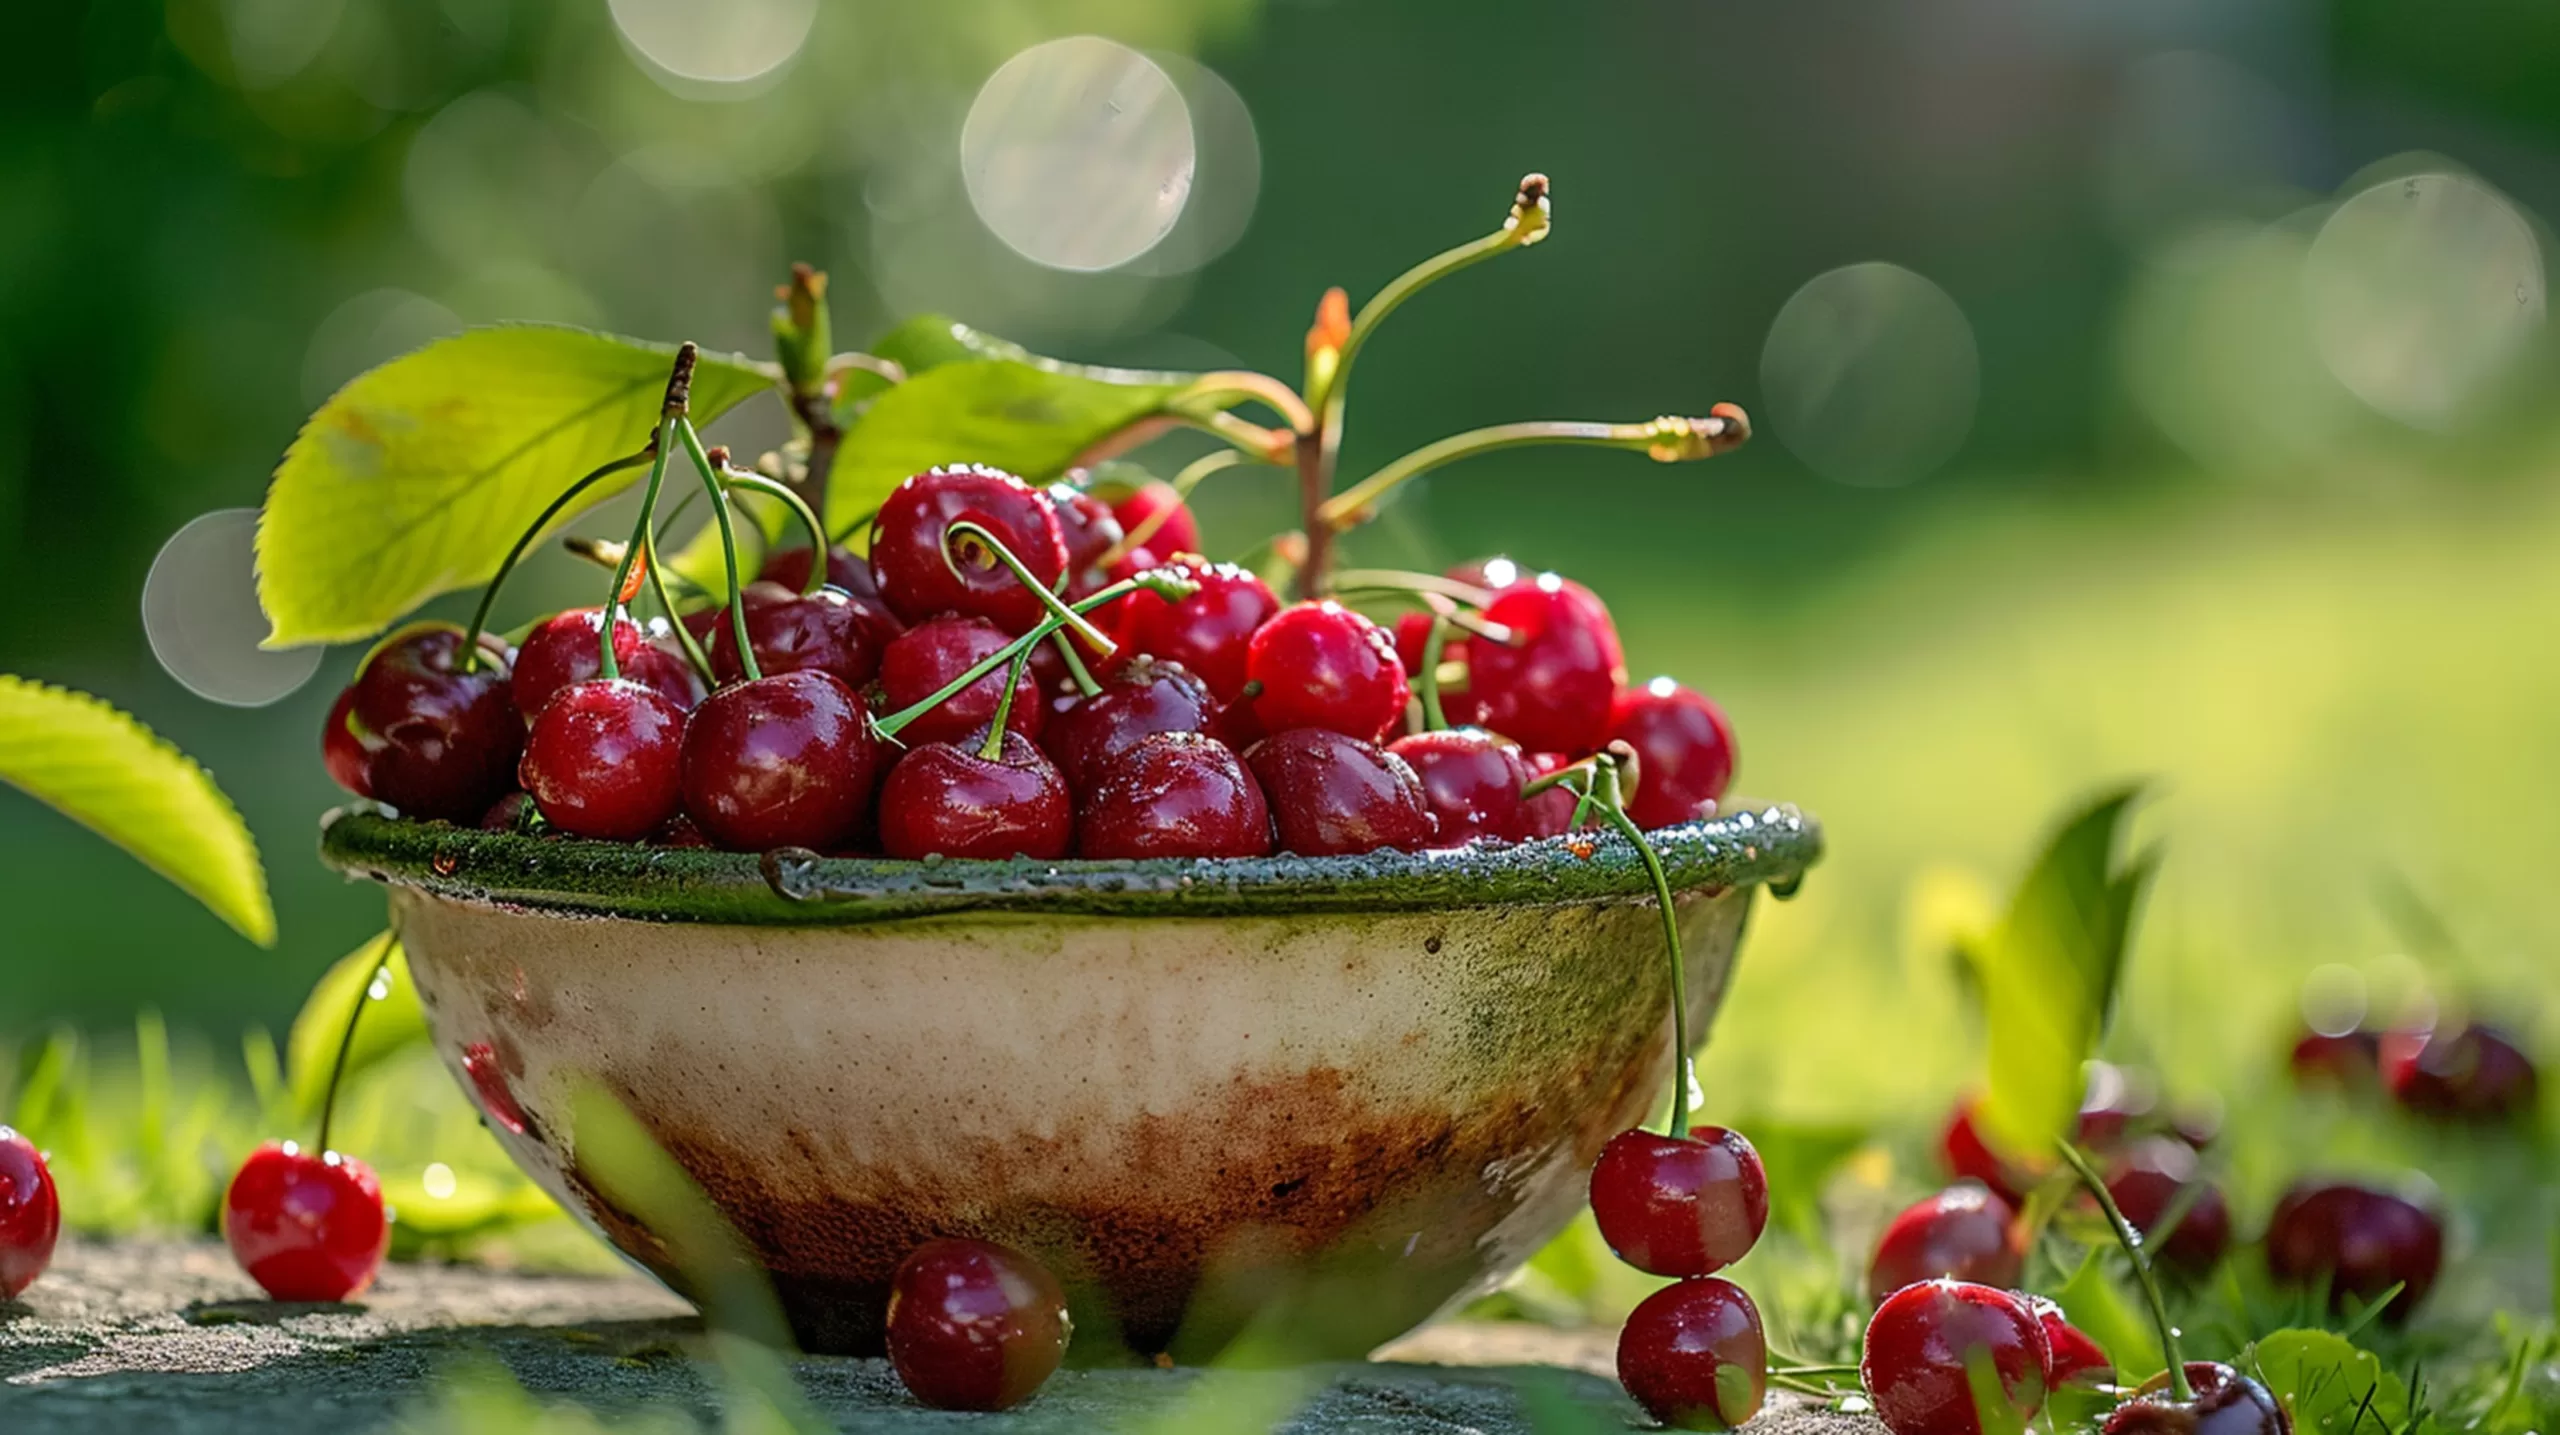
[{"xmin": 2301, "ymin": 174, "xmax": 2545, "ymax": 427}]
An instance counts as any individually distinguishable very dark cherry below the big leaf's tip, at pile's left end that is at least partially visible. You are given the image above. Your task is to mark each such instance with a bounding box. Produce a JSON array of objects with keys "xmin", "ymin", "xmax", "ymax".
[{"xmin": 348, "ymin": 624, "xmax": 525, "ymax": 821}]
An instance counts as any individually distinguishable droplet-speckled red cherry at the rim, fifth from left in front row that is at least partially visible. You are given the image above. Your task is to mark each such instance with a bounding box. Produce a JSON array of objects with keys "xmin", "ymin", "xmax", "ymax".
[{"xmin": 1075, "ymin": 732, "xmax": 1272, "ymax": 857}]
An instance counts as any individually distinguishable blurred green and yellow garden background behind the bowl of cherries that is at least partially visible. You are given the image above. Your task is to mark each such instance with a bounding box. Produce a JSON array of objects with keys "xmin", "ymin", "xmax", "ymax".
[{"xmin": 0, "ymin": 0, "xmax": 2560, "ymax": 1176}]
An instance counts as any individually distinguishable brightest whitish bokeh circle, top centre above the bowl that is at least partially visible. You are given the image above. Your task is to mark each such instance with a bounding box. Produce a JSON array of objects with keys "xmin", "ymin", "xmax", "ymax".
[{"xmin": 960, "ymin": 36, "xmax": 1198, "ymax": 271}]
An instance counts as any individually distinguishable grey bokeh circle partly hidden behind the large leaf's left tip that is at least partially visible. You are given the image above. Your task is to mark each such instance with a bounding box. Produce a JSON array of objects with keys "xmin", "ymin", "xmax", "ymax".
[{"xmin": 143, "ymin": 509, "xmax": 320, "ymax": 709}]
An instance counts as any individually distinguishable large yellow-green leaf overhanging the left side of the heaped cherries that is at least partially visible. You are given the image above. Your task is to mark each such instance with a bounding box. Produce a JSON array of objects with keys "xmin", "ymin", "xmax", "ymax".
[{"xmin": 259, "ymin": 325, "xmax": 773, "ymax": 647}]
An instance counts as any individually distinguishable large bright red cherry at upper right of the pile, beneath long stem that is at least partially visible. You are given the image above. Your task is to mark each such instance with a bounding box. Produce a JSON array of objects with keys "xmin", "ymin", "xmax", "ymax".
[{"xmin": 1467, "ymin": 573, "xmax": 1626, "ymax": 752}]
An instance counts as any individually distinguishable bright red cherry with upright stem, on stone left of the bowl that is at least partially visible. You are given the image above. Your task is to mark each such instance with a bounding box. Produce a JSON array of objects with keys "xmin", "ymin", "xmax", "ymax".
[{"xmin": 223, "ymin": 1141, "xmax": 392, "ymax": 1299}]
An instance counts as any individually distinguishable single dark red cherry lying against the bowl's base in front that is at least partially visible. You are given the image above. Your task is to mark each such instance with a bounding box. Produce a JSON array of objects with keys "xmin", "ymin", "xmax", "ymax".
[{"xmin": 888, "ymin": 1241, "xmax": 1073, "ymax": 1409}]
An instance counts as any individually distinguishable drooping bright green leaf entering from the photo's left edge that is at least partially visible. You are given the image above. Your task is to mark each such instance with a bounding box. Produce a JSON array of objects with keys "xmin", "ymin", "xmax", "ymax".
[{"xmin": 0, "ymin": 673, "xmax": 276, "ymax": 946}]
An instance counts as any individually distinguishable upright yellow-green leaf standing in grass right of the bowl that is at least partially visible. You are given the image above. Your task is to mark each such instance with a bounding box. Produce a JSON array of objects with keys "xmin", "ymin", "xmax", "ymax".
[{"xmin": 1966, "ymin": 788, "xmax": 2158, "ymax": 1164}]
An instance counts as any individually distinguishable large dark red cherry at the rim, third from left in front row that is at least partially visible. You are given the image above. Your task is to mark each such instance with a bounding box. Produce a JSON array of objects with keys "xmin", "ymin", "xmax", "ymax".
[{"xmin": 684, "ymin": 673, "xmax": 883, "ymax": 852}]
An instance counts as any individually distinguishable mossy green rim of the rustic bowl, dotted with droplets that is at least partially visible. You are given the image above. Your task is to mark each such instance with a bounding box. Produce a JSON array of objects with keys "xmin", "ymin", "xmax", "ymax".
[{"xmin": 320, "ymin": 803, "xmax": 1823, "ymax": 926}]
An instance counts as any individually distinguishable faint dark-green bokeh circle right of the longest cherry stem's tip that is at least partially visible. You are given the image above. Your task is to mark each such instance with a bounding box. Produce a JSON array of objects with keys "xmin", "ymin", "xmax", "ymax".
[{"xmin": 1761, "ymin": 261, "xmax": 1981, "ymax": 489}]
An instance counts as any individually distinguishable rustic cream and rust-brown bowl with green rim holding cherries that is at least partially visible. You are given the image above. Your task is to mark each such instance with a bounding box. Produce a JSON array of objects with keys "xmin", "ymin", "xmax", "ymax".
[{"xmin": 320, "ymin": 806, "xmax": 1820, "ymax": 1358}]
